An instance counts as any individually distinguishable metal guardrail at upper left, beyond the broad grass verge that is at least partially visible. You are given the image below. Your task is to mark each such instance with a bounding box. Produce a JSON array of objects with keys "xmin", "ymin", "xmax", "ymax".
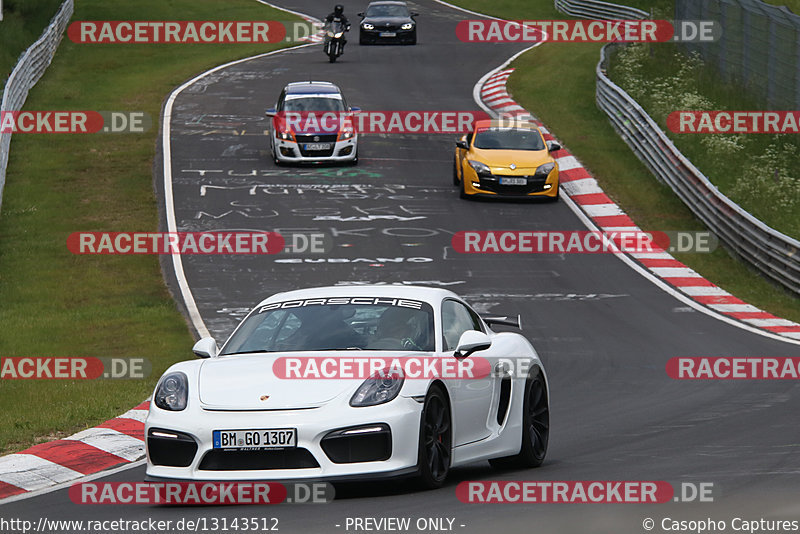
[{"xmin": 0, "ymin": 0, "xmax": 75, "ymax": 214}]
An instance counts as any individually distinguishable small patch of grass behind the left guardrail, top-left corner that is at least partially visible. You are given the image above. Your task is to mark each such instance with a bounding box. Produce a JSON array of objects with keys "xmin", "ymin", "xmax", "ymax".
[{"xmin": 0, "ymin": 0, "xmax": 63, "ymax": 88}]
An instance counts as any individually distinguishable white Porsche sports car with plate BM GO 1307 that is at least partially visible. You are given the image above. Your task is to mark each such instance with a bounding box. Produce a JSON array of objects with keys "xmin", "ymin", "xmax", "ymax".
[{"xmin": 145, "ymin": 285, "xmax": 549, "ymax": 487}]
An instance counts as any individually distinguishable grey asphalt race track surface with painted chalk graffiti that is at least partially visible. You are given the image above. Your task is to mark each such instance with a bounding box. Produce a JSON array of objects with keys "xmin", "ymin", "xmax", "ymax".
[{"xmin": 2, "ymin": 0, "xmax": 800, "ymax": 534}]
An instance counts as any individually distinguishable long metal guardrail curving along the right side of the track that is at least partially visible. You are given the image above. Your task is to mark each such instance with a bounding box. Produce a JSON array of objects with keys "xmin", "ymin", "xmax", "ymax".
[{"xmin": 555, "ymin": 0, "xmax": 800, "ymax": 294}]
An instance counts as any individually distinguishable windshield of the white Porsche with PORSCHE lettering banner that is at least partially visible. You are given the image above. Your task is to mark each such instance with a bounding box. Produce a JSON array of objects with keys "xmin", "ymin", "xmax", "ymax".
[{"xmin": 220, "ymin": 297, "xmax": 435, "ymax": 356}]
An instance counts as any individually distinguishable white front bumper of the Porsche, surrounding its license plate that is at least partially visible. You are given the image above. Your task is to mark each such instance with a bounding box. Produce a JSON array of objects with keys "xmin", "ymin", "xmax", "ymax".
[{"xmin": 145, "ymin": 397, "xmax": 422, "ymax": 481}]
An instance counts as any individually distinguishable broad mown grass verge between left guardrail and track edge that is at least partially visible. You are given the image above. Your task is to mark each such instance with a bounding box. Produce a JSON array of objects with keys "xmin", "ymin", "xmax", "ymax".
[{"xmin": 0, "ymin": 0, "xmax": 294, "ymax": 453}]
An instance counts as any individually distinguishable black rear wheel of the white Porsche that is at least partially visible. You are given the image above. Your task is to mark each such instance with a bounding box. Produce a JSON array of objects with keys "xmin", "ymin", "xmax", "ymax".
[{"xmin": 489, "ymin": 373, "xmax": 550, "ymax": 469}]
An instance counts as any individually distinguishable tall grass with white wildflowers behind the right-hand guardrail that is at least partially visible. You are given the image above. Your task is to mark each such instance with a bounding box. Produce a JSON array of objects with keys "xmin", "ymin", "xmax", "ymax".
[{"xmin": 608, "ymin": 43, "xmax": 800, "ymax": 239}]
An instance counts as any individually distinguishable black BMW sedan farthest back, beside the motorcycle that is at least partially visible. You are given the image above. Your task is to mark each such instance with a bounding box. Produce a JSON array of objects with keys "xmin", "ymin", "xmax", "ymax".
[{"xmin": 358, "ymin": 0, "xmax": 417, "ymax": 44}]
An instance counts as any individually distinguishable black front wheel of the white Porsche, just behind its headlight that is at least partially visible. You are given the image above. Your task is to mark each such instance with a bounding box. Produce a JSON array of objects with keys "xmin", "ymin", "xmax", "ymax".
[{"xmin": 417, "ymin": 386, "xmax": 453, "ymax": 489}]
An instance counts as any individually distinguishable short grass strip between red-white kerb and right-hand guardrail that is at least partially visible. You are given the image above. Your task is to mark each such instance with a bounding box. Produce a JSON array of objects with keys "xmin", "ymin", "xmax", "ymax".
[{"xmin": 450, "ymin": 0, "xmax": 800, "ymax": 321}]
